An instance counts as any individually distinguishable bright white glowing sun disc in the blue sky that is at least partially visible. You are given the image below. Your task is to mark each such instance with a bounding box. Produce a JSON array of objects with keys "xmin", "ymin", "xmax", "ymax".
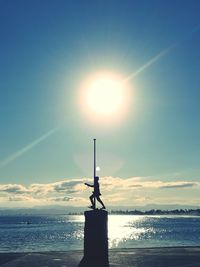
[{"xmin": 80, "ymin": 74, "xmax": 129, "ymax": 124}]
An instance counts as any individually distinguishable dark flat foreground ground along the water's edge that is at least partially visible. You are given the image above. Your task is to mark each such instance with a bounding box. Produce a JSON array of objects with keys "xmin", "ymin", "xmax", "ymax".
[{"xmin": 0, "ymin": 247, "xmax": 200, "ymax": 267}]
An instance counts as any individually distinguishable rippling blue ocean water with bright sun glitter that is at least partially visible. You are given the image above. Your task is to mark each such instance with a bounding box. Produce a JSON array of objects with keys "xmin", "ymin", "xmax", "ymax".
[{"xmin": 0, "ymin": 215, "xmax": 200, "ymax": 252}]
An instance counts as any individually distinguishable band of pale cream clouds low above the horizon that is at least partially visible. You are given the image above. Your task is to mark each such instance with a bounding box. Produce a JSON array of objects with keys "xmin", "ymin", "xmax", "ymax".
[{"xmin": 0, "ymin": 176, "xmax": 200, "ymax": 206}]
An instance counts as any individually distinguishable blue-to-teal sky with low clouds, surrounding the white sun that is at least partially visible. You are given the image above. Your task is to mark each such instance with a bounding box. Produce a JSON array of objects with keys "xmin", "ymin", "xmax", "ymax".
[{"xmin": 0, "ymin": 0, "xmax": 200, "ymax": 207}]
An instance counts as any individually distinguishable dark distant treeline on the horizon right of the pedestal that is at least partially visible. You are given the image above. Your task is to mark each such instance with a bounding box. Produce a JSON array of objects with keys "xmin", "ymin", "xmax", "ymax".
[{"xmin": 109, "ymin": 209, "xmax": 200, "ymax": 216}]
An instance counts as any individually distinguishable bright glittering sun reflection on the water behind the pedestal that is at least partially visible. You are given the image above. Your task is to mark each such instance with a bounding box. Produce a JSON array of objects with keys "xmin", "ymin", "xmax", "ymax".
[{"xmin": 65, "ymin": 215, "xmax": 155, "ymax": 248}]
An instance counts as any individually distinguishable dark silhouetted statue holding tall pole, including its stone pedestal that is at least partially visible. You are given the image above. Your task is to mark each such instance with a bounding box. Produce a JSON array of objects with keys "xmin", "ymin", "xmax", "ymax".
[{"xmin": 78, "ymin": 139, "xmax": 109, "ymax": 267}]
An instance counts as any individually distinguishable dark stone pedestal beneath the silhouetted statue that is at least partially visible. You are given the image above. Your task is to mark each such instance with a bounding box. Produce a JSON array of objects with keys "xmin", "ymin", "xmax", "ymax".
[{"xmin": 79, "ymin": 210, "xmax": 109, "ymax": 267}]
